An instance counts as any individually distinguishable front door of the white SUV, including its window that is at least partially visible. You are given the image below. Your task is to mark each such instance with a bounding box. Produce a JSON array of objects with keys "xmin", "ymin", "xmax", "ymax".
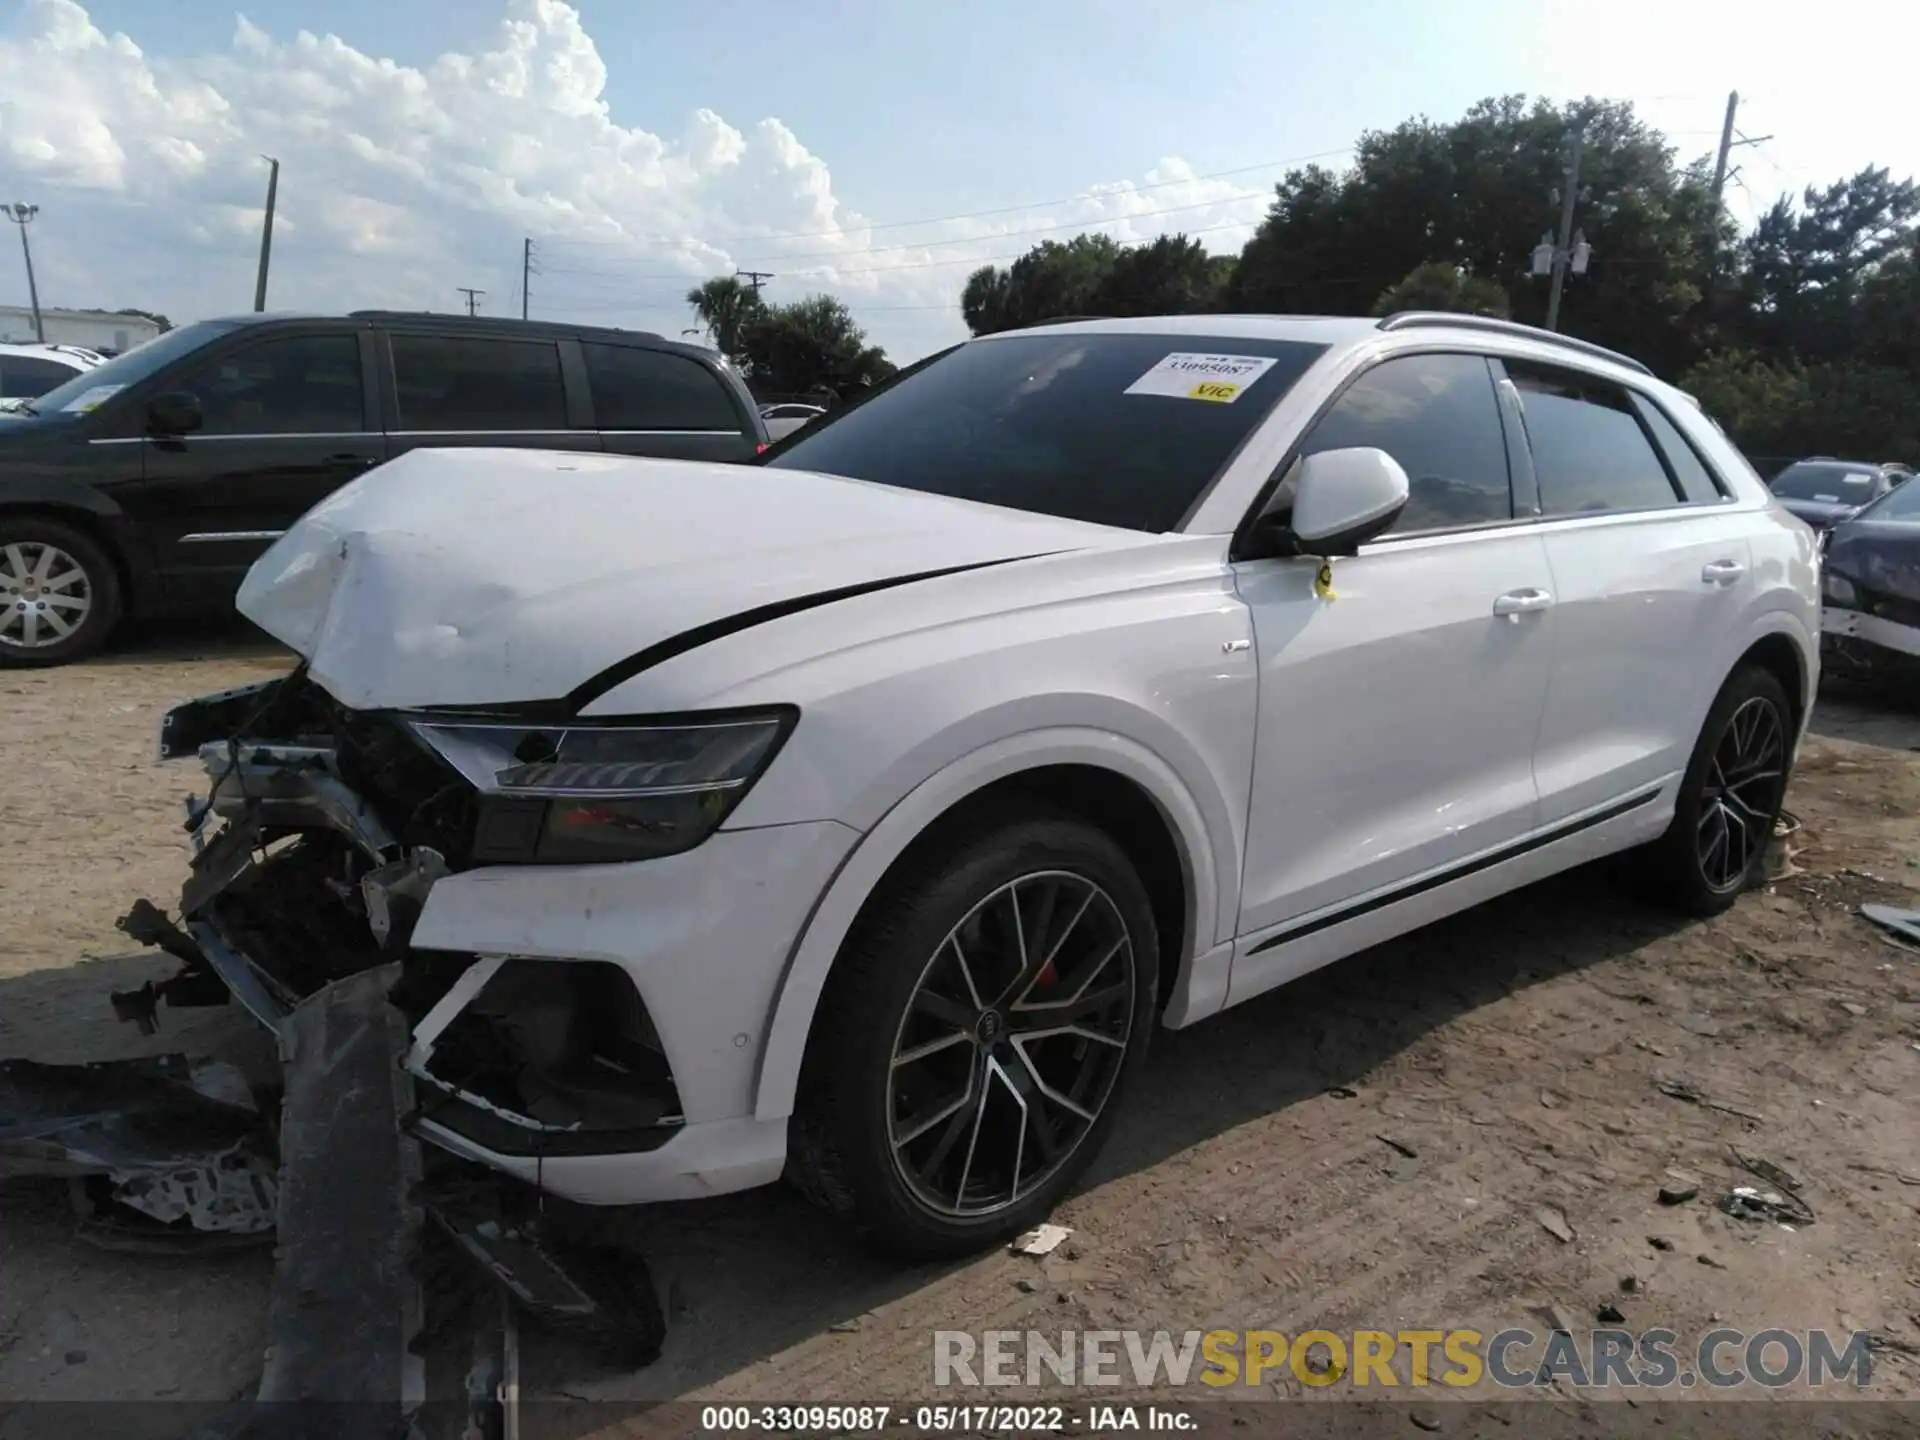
[{"xmin": 1229, "ymin": 353, "xmax": 1553, "ymax": 1000}]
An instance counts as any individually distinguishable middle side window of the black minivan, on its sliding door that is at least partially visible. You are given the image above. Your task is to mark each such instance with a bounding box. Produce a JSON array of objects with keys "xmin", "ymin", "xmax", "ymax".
[{"xmin": 390, "ymin": 334, "xmax": 566, "ymax": 430}]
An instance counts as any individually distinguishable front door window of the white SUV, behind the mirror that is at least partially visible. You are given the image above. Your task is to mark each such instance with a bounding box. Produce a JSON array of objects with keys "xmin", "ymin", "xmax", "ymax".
[{"xmin": 1300, "ymin": 355, "xmax": 1513, "ymax": 534}]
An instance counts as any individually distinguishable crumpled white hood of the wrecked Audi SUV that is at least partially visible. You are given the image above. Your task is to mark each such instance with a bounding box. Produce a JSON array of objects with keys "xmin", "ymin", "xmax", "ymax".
[{"xmin": 238, "ymin": 449, "xmax": 1121, "ymax": 708}]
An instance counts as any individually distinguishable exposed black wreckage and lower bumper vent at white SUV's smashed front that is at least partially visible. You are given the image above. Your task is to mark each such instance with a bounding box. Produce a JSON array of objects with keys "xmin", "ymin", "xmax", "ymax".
[{"xmin": 125, "ymin": 670, "xmax": 684, "ymax": 1158}]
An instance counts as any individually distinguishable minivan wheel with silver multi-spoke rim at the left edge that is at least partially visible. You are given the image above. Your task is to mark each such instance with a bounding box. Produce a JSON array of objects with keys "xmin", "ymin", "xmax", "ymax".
[{"xmin": 0, "ymin": 515, "xmax": 121, "ymax": 666}]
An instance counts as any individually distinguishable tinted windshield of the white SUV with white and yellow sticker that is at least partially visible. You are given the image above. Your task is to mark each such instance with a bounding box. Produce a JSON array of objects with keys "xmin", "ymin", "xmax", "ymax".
[{"xmin": 766, "ymin": 332, "xmax": 1325, "ymax": 532}]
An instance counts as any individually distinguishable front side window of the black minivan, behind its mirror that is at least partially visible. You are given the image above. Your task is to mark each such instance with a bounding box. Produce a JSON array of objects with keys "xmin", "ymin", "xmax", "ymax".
[{"xmin": 167, "ymin": 334, "xmax": 367, "ymax": 436}]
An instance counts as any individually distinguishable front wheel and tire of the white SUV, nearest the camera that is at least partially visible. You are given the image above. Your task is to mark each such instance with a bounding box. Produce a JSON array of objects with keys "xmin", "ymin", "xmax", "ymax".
[{"xmin": 789, "ymin": 808, "xmax": 1160, "ymax": 1260}]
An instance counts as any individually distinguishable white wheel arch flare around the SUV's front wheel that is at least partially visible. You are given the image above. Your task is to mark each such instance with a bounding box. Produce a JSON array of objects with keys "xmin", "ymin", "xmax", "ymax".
[{"xmin": 755, "ymin": 728, "xmax": 1238, "ymax": 1119}]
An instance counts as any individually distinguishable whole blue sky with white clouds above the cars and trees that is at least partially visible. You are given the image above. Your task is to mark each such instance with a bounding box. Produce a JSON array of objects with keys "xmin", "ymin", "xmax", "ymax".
[{"xmin": 0, "ymin": 0, "xmax": 1920, "ymax": 363}]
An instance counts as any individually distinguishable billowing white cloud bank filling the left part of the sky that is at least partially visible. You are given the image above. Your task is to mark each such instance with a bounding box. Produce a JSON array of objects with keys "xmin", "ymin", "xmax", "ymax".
[{"xmin": 0, "ymin": 0, "xmax": 1271, "ymax": 359}]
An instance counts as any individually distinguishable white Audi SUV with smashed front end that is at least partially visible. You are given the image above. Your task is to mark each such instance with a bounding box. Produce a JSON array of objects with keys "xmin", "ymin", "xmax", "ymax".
[{"xmin": 161, "ymin": 315, "xmax": 1820, "ymax": 1256}]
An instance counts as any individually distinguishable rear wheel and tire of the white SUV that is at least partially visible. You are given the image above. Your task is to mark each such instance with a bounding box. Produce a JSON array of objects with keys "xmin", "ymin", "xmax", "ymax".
[{"xmin": 1644, "ymin": 666, "xmax": 1793, "ymax": 916}]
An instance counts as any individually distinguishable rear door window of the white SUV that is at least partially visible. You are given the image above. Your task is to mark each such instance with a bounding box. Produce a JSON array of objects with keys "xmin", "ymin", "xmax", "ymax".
[{"xmin": 1507, "ymin": 361, "xmax": 1680, "ymax": 515}]
